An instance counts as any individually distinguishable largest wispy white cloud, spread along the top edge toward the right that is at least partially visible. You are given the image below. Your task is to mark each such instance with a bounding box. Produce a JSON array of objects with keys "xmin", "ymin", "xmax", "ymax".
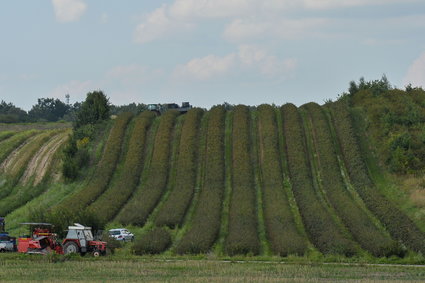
[{"xmin": 135, "ymin": 0, "xmax": 420, "ymax": 43}]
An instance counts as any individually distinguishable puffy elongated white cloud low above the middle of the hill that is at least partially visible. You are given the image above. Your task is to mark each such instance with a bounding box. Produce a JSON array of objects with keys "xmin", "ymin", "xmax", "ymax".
[{"xmin": 174, "ymin": 45, "xmax": 297, "ymax": 80}]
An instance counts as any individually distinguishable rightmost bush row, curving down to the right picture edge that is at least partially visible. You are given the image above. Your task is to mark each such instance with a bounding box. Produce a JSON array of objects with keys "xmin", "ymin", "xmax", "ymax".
[{"xmin": 331, "ymin": 101, "xmax": 425, "ymax": 254}]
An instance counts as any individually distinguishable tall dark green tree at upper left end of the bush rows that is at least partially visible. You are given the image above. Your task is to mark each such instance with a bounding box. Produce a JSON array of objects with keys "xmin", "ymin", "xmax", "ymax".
[{"xmin": 75, "ymin": 90, "xmax": 110, "ymax": 128}]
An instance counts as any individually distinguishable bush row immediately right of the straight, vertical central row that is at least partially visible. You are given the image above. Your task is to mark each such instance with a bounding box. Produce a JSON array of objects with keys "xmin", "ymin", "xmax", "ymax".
[{"xmin": 258, "ymin": 105, "xmax": 307, "ymax": 256}]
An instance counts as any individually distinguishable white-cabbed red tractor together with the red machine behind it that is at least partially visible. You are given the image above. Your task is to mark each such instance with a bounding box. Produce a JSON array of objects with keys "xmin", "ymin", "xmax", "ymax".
[{"xmin": 18, "ymin": 223, "xmax": 106, "ymax": 257}]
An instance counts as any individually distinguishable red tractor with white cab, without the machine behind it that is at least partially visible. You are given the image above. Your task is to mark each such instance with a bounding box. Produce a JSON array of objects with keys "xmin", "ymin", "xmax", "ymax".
[{"xmin": 62, "ymin": 223, "xmax": 106, "ymax": 256}]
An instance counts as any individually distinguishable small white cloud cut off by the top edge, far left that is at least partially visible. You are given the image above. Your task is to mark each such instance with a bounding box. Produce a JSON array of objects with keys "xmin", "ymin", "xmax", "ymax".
[{"xmin": 52, "ymin": 0, "xmax": 87, "ymax": 23}]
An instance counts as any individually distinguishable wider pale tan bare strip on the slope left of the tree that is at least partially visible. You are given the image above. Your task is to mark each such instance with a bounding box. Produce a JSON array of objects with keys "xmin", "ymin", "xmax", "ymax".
[{"xmin": 20, "ymin": 132, "xmax": 68, "ymax": 186}]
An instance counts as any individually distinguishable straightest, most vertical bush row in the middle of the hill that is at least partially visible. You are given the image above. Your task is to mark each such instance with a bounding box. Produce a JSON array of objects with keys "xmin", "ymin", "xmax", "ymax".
[{"xmin": 225, "ymin": 105, "xmax": 260, "ymax": 255}]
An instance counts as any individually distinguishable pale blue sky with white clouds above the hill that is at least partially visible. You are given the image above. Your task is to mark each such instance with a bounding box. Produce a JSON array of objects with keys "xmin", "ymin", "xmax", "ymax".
[{"xmin": 0, "ymin": 0, "xmax": 425, "ymax": 110}]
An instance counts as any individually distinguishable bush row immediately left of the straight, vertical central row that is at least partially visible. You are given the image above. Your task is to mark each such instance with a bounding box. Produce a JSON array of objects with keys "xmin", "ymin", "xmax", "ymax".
[{"xmin": 176, "ymin": 106, "xmax": 226, "ymax": 254}]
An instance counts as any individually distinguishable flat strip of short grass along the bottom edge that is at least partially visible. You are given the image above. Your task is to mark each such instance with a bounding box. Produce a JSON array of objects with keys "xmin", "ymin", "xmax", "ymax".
[{"xmin": 0, "ymin": 254, "xmax": 425, "ymax": 282}]
